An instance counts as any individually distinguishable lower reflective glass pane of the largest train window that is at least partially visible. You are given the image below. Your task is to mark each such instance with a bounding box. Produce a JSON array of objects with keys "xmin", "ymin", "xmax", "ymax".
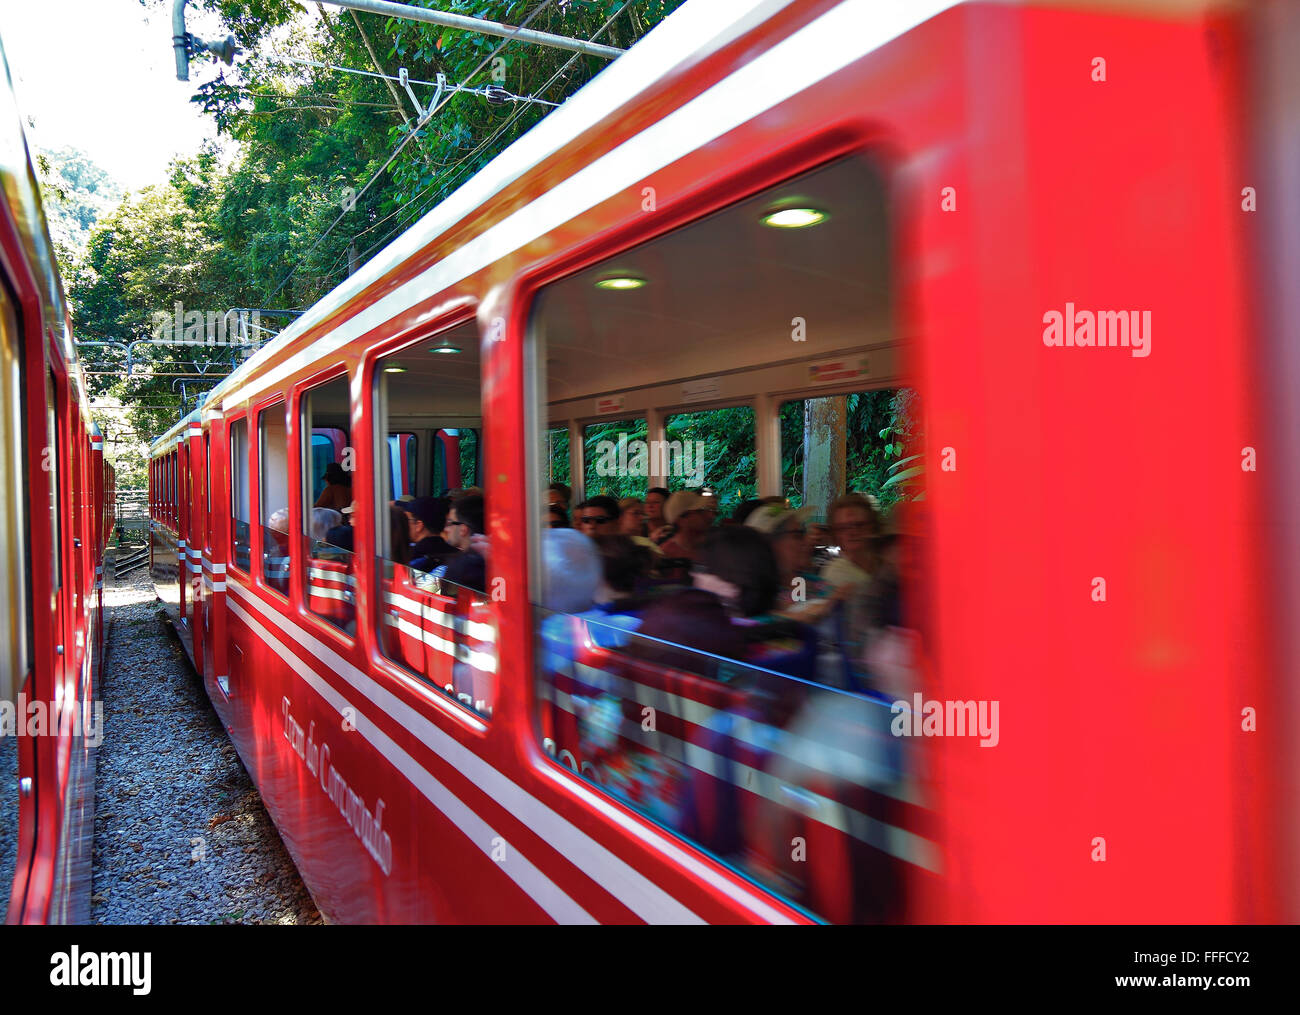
[{"xmin": 537, "ymin": 610, "xmax": 909, "ymax": 923}]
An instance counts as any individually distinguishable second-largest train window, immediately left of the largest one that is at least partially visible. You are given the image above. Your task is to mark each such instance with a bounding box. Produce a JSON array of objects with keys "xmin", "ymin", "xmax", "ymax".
[{"xmin": 374, "ymin": 325, "xmax": 497, "ymax": 717}]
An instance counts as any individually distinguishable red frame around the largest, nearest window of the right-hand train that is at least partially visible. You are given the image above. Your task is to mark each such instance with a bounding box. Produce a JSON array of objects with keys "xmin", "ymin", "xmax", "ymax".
[{"xmin": 517, "ymin": 142, "xmax": 906, "ymax": 920}]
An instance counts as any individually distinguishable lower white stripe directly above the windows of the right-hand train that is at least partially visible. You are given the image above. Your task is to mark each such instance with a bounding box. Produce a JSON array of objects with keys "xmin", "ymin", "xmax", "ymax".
[{"xmin": 221, "ymin": 0, "xmax": 954, "ymax": 411}]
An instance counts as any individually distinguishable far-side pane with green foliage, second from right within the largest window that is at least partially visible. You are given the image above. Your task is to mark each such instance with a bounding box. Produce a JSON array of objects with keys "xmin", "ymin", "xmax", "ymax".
[{"xmin": 653, "ymin": 405, "xmax": 758, "ymax": 515}]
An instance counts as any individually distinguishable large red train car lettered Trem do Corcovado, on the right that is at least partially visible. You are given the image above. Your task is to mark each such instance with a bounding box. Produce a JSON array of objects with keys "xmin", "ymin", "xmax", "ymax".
[{"xmin": 151, "ymin": 0, "xmax": 1296, "ymax": 923}]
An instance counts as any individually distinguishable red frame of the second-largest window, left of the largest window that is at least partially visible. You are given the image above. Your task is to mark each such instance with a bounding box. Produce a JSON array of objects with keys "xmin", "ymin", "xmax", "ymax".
[{"xmin": 354, "ymin": 304, "xmax": 491, "ymax": 739}]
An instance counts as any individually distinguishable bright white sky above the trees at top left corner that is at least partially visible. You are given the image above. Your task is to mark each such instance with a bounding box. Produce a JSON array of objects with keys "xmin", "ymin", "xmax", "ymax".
[{"xmin": 0, "ymin": 0, "xmax": 237, "ymax": 190}]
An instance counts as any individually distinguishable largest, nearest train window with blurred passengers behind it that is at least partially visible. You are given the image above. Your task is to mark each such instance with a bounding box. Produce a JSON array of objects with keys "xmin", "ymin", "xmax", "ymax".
[{"xmin": 528, "ymin": 152, "xmax": 937, "ymax": 921}]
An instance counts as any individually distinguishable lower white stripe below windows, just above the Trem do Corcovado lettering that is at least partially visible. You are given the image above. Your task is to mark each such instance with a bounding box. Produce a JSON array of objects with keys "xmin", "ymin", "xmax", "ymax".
[{"xmin": 226, "ymin": 595, "xmax": 597, "ymax": 924}]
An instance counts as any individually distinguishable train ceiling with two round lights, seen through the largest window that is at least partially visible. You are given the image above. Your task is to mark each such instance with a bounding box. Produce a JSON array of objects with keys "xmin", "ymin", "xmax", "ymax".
[{"xmin": 534, "ymin": 160, "xmax": 891, "ymax": 402}]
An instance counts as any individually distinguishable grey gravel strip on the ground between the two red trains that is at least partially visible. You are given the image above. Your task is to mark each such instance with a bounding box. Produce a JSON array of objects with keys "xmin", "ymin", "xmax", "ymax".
[{"xmin": 91, "ymin": 567, "xmax": 321, "ymax": 924}]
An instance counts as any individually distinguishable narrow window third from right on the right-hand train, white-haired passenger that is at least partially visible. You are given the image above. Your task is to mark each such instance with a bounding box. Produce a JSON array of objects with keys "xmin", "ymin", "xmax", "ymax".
[{"xmin": 300, "ymin": 376, "xmax": 356, "ymax": 634}]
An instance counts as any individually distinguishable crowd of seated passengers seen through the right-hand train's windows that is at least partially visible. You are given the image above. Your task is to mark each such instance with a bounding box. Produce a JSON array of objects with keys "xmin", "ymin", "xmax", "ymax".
[{"xmin": 279, "ymin": 464, "xmax": 910, "ymax": 690}]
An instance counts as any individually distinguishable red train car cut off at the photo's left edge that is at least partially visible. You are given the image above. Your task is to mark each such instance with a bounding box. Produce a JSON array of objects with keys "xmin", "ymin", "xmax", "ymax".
[{"xmin": 0, "ymin": 35, "xmax": 114, "ymax": 923}]
